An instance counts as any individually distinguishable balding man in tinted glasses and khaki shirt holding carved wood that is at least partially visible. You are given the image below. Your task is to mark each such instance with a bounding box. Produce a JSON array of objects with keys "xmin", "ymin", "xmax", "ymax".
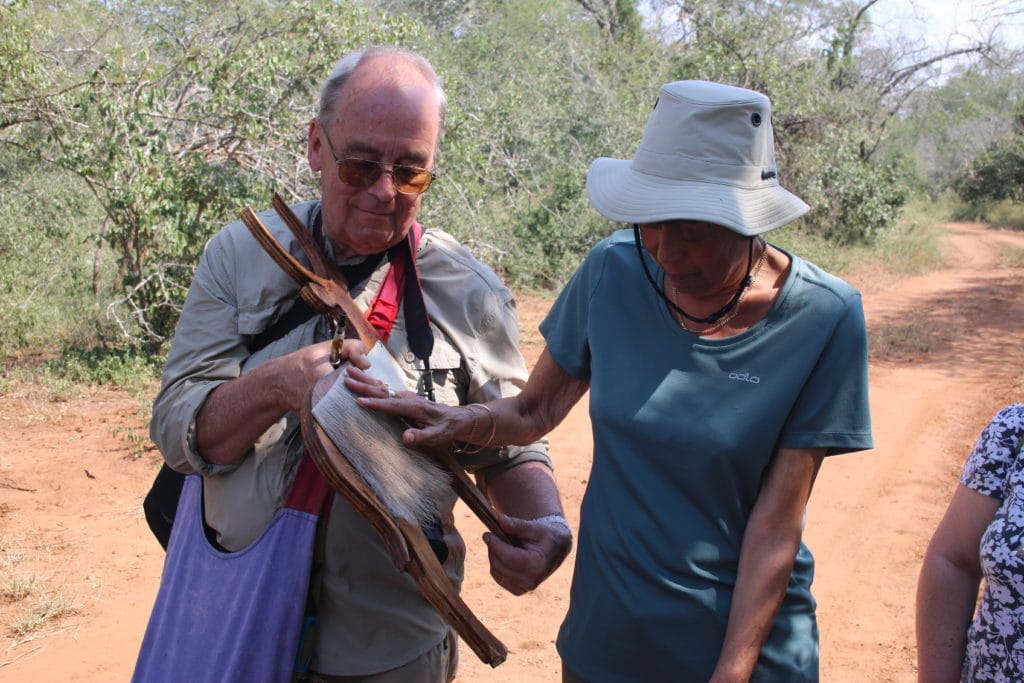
[{"xmin": 151, "ymin": 47, "xmax": 571, "ymax": 683}]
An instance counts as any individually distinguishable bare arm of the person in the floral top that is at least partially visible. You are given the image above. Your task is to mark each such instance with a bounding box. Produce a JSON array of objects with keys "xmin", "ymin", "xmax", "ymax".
[{"xmin": 916, "ymin": 484, "xmax": 999, "ymax": 683}]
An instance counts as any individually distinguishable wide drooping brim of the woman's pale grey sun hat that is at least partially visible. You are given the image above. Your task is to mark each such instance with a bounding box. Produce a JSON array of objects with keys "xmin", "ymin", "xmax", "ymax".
[{"xmin": 587, "ymin": 158, "xmax": 810, "ymax": 236}]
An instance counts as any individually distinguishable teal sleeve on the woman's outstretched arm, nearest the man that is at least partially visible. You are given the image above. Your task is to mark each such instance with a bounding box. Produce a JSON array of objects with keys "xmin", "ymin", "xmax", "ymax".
[{"xmin": 541, "ymin": 242, "xmax": 605, "ymax": 382}]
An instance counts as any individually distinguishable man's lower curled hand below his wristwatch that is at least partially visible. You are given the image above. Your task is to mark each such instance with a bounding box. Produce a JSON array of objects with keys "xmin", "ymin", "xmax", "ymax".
[{"xmin": 483, "ymin": 515, "xmax": 572, "ymax": 595}]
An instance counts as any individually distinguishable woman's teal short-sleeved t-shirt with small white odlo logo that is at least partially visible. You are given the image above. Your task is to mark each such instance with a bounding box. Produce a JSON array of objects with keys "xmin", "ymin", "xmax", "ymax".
[{"xmin": 541, "ymin": 230, "xmax": 871, "ymax": 683}]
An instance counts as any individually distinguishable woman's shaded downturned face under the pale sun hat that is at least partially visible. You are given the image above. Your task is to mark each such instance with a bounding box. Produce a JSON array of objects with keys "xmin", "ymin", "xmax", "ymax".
[{"xmin": 640, "ymin": 220, "xmax": 750, "ymax": 296}]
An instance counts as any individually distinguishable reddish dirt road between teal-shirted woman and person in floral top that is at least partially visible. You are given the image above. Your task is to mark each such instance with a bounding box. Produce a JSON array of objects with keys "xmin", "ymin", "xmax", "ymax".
[{"xmin": 805, "ymin": 223, "xmax": 1024, "ymax": 683}]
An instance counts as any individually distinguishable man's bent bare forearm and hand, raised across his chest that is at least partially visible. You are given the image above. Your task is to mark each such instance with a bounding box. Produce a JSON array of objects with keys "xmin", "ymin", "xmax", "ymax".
[{"xmin": 196, "ymin": 340, "xmax": 367, "ymax": 464}]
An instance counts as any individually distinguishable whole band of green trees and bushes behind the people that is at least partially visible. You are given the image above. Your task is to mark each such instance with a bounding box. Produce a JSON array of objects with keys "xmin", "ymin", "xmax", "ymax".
[{"xmin": 0, "ymin": 0, "xmax": 1013, "ymax": 352}]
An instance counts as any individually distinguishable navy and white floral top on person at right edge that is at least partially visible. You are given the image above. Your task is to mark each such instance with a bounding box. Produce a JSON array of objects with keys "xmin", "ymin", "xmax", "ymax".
[{"xmin": 959, "ymin": 403, "xmax": 1024, "ymax": 683}]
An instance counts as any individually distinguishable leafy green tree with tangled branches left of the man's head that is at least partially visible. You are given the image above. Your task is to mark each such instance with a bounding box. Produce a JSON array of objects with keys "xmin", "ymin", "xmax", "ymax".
[{"xmin": 0, "ymin": 0, "xmax": 415, "ymax": 342}]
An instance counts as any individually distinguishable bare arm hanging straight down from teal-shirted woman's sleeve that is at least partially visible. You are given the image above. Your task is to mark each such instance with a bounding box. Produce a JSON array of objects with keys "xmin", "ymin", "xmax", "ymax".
[{"xmin": 711, "ymin": 449, "xmax": 825, "ymax": 683}]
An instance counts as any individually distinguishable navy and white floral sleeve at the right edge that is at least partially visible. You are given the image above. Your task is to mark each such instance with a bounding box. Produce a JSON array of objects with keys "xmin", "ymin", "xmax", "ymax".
[{"xmin": 959, "ymin": 403, "xmax": 1024, "ymax": 500}]
